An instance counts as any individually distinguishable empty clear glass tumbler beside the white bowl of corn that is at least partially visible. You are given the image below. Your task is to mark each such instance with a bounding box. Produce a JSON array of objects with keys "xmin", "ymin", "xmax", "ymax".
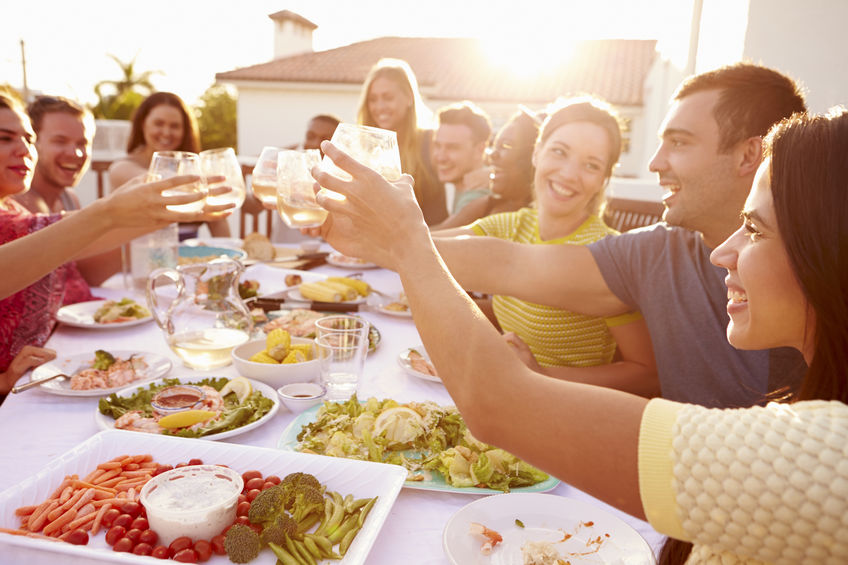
[{"xmin": 315, "ymin": 332, "xmax": 368, "ymax": 401}]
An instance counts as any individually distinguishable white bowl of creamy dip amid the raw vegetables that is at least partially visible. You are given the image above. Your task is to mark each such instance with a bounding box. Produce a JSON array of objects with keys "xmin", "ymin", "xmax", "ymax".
[{"xmin": 139, "ymin": 465, "xmax": 244, "ymax": 545}]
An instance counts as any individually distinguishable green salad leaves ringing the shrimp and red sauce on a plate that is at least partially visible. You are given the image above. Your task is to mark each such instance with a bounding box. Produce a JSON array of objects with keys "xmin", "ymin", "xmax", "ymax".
[{"xmin": 98, "ymin": 377, "xmax": 274, "ymax": 437}]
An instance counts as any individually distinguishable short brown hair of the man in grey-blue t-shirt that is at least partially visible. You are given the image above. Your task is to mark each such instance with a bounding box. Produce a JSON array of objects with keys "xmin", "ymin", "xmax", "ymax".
[{"xmin": 674, "ymin": 63, "xmax": 807, "ymax": 152}]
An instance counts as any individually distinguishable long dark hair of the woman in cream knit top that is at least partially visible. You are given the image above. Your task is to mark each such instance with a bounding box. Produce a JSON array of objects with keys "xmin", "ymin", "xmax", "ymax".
[{"xmin": 764, "ymin": 108, "xmax": 848, "ymax": 402}]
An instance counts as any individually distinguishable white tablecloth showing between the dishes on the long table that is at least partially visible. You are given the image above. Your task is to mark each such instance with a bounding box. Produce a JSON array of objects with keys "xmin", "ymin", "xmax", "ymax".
[{"xmin": 0, "ymin": 247, "xmax": 665, "ymax": 565}]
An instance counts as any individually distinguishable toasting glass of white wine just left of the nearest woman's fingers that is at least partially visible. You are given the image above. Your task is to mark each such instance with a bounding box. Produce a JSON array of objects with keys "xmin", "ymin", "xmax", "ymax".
[{"xmin": 277, "ymin": 149, "xmax": 327, "ymax": 228}]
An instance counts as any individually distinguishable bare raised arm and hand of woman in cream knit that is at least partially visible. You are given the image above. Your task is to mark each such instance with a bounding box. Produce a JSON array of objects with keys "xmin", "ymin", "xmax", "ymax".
[{"xmin": 314, "ymin": 142, "xmax": 647, "ymax": 516}]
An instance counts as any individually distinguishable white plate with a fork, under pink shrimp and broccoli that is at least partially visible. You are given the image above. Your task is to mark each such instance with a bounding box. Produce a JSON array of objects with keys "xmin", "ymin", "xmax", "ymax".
[{"xmin": 29, "ymin": 350, "xmax": 171, "ymax": 396}]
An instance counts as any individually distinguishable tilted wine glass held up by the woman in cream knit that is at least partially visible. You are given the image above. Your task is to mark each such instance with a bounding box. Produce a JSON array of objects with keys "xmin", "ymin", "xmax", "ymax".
[{"xmin": 321, "ymin": 124, "xmax": 401, "ymax": 181}]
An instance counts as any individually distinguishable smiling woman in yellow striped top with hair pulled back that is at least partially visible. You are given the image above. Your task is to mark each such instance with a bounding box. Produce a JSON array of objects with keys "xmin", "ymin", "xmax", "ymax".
[{"xmin": 433, "ymin": 97, "xmax": 659, "ymax": 396}]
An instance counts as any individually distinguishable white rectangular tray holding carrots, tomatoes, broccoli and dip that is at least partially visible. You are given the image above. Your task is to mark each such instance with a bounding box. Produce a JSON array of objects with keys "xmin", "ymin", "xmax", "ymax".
[{"xmin": 0, "ymin": 430, "xmax": 406, "ymax": 565}]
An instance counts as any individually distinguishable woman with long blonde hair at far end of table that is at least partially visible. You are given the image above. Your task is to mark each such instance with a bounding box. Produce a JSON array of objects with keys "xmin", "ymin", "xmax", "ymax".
[{"xmin": 356, "ymin": 59, "xmax": 448, "ymax": 225}]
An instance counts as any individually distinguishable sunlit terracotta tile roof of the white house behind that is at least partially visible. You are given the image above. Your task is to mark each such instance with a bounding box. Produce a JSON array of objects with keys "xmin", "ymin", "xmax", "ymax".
[{"xmin": 216, "ymin": 37, "xmax": 656, "ymax": 106}]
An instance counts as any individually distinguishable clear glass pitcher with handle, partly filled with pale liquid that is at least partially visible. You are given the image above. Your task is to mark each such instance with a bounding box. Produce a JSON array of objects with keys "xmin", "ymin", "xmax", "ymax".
[{"xmin": 147, "ymin": 257, "xmax": 253, "ymax": 370}]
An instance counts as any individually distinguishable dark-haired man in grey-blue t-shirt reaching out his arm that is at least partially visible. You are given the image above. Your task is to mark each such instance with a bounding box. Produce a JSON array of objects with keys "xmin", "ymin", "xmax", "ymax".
[{"xmin": 437, "ymin": 63, "xmax": 805, "ymax": 407}]
